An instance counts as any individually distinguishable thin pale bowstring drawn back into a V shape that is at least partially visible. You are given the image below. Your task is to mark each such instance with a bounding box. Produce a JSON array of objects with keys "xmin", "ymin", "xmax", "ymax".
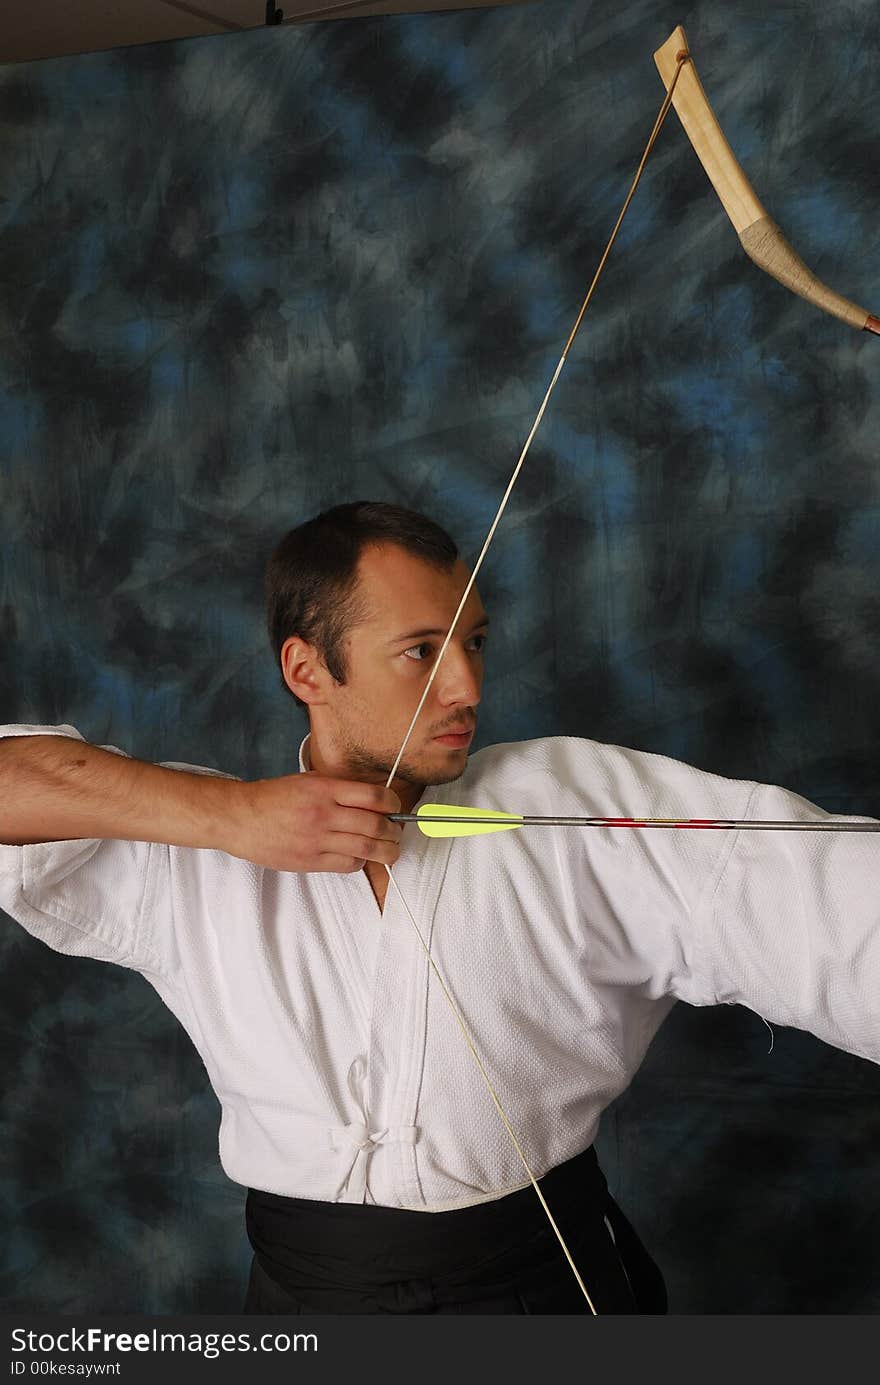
[{"xmin": 385, "ymin": 50, "xmax": 690, "ymax": 1317}]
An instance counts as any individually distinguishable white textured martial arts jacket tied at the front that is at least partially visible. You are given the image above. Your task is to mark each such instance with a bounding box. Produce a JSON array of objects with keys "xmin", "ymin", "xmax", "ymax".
[{"xmin": 0, "ymin": 726, "xmax": 880, "ymax": 1212}]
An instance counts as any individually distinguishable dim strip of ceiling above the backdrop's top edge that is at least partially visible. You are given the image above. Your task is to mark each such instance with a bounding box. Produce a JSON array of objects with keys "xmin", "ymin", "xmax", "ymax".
[{"xmin": 0, "ymin": 0, "xmax": 520, "ymax": 62}]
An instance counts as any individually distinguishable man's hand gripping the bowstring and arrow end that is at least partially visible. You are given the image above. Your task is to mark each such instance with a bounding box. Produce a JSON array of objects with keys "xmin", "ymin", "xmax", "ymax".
[{"xmin": 222, "ymin": 771, "xmax": 403, "ymax": 875}]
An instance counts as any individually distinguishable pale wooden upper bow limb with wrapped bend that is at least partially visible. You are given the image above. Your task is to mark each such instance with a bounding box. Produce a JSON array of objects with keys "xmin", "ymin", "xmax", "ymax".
[{"xmin": 654, "ymin": 25, "xmax": 880, "ymax": 335}]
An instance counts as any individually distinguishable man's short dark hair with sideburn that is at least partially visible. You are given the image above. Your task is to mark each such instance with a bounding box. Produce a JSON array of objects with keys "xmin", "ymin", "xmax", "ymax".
[{"xmin": 265, "ymin": 500, "xmax": 459, "ymax": 706}]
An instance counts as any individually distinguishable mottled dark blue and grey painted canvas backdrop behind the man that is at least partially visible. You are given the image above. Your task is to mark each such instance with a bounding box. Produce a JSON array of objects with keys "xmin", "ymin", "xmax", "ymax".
[{"xmin": 0, "ymin": 0, "xmax": 880, "ymax": 1313}]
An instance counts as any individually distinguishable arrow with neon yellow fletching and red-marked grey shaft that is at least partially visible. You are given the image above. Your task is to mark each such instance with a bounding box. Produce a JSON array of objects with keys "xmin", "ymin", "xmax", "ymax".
[{"xmin": 388, "ymin": 803, "xmax": 880, "ymax": 837}]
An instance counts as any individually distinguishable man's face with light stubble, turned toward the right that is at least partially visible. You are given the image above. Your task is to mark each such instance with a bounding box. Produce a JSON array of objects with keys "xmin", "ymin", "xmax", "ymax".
[{"xmin": 310, "ymin": 543, "xmax": 488, "ymax": 785}]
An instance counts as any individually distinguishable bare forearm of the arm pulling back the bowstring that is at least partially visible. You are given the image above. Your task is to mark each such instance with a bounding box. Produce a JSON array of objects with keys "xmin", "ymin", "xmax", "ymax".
[{"xmin": 0, "ymin": 735, "xmax": 243, "ymax": 848}]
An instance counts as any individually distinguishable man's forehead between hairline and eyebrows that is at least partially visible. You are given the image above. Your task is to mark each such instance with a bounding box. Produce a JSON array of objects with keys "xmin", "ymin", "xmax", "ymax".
[{"xmin": 358, "ymin": 543, "xmax": 482, "ymax": 625}]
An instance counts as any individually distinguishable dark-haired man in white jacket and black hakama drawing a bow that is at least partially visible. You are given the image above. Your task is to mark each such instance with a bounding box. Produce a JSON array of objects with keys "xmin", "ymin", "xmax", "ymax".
[{"xmin": 0, "ymin": 503, "xmax": 880, "ymax": 1313}]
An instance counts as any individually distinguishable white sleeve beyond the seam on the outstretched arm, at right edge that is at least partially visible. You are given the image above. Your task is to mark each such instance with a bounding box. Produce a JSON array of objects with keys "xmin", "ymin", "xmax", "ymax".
[{"xmin": 687, "ymin": 784, "xmax": 880, "ymax": 1062}]
